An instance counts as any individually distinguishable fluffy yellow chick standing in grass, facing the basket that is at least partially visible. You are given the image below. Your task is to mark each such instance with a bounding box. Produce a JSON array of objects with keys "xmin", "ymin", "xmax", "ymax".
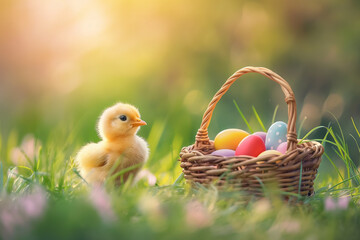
[{"xmin": 76, "ymin": 103, "xmax": 149, "ymax": 184}]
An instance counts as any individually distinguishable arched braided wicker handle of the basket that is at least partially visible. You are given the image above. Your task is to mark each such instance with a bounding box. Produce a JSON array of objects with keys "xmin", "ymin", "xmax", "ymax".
[{"xmin": 194, "ymin": 67, "xmax": 297, "ymax": 151}]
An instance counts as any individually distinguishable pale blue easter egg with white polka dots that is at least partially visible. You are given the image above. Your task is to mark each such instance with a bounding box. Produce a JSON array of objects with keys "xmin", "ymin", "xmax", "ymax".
[{"xmin": 265, "ymin": 121, "xmax": 287, "ymax": 150}]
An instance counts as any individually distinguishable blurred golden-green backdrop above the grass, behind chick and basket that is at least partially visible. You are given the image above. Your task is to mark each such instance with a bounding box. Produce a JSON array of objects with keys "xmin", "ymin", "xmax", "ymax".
[{"xmin": 0, "ymin": 0, "xmax": 360, "ymax": 172}]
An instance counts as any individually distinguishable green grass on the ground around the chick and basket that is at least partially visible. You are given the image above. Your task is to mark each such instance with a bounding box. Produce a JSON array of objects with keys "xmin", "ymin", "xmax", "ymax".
[{"xmin": 0, "ymin": 109, "xmax": 360, "ymax": 239}]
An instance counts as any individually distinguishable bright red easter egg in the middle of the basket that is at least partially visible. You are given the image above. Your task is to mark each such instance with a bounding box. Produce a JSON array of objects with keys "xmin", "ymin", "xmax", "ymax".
[{"xmin": 235, "ymin": 135, "xmax": 266, "ymax": 157}]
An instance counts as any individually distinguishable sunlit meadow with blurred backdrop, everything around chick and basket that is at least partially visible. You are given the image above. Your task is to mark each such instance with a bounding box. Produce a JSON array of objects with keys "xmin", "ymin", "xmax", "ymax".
[{"xmin": 0, "ymin": 0, "xmax": 360, "ymax": 240}]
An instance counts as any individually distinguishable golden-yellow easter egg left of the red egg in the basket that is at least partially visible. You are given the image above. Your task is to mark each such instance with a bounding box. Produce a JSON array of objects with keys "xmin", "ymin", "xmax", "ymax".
[{"xmin": 214, "ymin": 128, "xmax": 249, "ymax": 150}]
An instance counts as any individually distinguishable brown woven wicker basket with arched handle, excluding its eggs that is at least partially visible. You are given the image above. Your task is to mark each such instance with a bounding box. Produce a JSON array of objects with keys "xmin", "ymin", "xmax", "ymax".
[{"xmin": 180, "ymin": 67, "xmax": 324, "ymax": 196}]
